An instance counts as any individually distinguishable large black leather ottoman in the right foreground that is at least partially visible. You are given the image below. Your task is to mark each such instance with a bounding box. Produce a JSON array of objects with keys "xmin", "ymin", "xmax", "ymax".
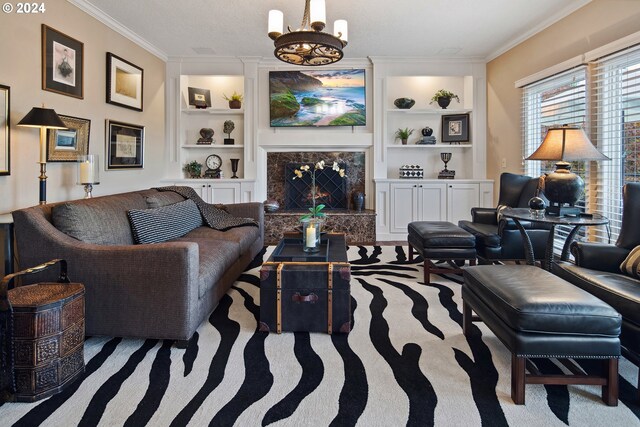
[{"xmin": 462, "ymin": 265, "xmax": 621, "ymax": 406}]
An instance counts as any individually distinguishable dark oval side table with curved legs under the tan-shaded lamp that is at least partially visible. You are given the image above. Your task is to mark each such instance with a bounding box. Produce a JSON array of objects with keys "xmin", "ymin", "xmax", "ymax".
[{"xmin": 500, "ymin": 208, "xmax": 609, "ymax": 270}]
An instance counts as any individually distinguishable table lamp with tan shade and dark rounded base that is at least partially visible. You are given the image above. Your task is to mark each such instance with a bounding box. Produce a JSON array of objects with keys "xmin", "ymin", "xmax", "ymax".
[{"xmin": 526, "ymin": 125, "xmax": 609, "ymax": 216}]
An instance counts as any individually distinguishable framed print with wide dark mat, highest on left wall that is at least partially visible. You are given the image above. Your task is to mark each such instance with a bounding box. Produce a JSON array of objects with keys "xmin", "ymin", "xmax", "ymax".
[{"xmin": 42, "ymin": 24, "xmax": 84, "ymax": 99}]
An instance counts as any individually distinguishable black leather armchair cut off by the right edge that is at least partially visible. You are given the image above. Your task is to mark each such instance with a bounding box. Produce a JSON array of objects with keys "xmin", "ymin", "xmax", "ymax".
[{"xmin": 551, "ymin": 182, "xmax": 640, "ymax": 401}]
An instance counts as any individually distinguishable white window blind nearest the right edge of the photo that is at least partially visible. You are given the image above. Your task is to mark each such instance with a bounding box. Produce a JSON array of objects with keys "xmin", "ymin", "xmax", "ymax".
[{"xmin": 591, "ymin": 46, "xmax": 640, "ymax": 241}]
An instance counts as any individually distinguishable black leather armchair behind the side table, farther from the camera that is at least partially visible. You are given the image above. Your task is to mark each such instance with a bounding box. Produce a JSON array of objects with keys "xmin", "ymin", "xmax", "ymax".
[{"xmin": 458, "ymin": 172, "xmax": 550, "ymax": 264}]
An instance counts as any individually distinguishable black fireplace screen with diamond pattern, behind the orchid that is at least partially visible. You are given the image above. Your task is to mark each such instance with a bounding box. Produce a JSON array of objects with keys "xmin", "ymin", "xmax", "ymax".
[{"xmin": 285, "ymin": 163, "xmax": 348, "ymax": 209}]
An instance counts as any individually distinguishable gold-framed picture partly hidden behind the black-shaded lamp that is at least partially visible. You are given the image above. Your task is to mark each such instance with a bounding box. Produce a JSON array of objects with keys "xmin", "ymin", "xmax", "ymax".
[{"xmin": 47, "ymin": 114, "xmax": 91, "ymax": 162}]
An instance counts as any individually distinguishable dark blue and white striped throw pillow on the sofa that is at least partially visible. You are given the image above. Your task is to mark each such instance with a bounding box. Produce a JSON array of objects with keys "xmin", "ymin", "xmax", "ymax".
[{"xmin": 127, "ymin": 200, "xmax": 202, "ymax": 244}]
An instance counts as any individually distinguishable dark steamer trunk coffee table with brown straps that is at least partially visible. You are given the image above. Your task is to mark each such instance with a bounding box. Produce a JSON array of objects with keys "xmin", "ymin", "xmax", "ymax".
[{"xmin": 260, "ymin": 233, "xmax": 351, "ymax": 334}]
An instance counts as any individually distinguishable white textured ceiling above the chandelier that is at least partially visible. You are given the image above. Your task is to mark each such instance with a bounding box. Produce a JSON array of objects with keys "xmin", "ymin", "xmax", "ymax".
[{"xmin": 77, "ymin": 0, "xmax": 590, "ymax": 59}]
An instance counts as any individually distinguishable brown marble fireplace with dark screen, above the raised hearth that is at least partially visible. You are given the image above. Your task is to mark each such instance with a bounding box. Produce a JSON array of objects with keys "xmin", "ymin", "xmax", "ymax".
[{"xmin": 267, "ymin": 151, "xmax": 366, "ymax": 211}]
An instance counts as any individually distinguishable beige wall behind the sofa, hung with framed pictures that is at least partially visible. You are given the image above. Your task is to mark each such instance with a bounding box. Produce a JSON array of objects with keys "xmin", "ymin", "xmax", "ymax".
[{"xmin": 0, "ymin": 0, "xmax": 165, "ymax": 213}]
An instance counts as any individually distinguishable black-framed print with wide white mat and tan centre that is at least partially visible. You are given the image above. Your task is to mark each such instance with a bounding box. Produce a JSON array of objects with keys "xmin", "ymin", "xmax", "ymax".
[{"xmin": 107, "ymin": 52, "xmax": 144, "ymax": 111}]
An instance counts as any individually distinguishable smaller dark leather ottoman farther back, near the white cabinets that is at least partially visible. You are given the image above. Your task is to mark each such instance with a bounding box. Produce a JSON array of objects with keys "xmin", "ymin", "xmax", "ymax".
[{"xmin": 407, "ymin": 221, "xmax": 476, "ymax": 284}]
